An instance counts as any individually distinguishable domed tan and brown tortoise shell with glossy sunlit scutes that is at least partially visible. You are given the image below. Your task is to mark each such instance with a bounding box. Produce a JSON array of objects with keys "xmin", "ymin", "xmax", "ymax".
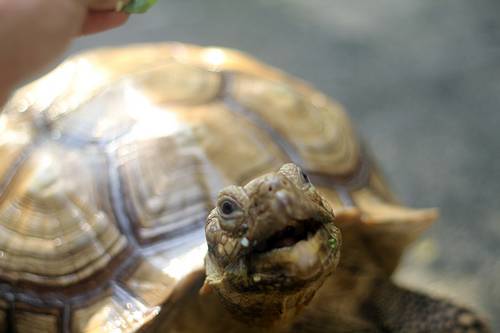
[{"xmin": 0, "ymin": 44, "xmax": 430, "ymax": 332}]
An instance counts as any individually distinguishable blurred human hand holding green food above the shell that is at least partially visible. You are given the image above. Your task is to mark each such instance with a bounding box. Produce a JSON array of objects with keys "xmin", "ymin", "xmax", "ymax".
[{"xmin": 0, "ymin": 0, "xmax": 128, "ymax": 106}]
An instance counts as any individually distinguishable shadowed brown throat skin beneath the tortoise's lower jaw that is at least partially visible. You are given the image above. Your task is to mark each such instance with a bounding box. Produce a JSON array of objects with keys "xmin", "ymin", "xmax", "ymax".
[{"xmin": 205, "ymin": 254, "xmax": 324, "ymax": 331}]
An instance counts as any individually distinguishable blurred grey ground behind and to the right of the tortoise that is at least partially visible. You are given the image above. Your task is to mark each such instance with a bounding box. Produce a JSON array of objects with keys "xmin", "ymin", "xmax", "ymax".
[{"xmin": 68, "ymin": 0, "xmax": 500, "ymax": 326}]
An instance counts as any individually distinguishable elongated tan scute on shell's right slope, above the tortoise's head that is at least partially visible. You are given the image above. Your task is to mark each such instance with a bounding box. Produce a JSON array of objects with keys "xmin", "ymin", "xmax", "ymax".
[{"xmin": 231, "ymin": 74, "xmax": 360, "ymax": 175}]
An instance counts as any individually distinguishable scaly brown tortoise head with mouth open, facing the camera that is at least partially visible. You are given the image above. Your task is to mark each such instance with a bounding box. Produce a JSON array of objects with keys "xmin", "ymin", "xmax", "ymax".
[{"xmin": 204, "ymin": 164, "xmax": 341, "ymax": 325}]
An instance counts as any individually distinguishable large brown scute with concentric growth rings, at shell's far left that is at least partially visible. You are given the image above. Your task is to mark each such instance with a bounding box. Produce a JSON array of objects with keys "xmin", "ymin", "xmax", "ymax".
[{"xmin": 0, "ymin": 146, "xmax": 126, "ymax": 286}]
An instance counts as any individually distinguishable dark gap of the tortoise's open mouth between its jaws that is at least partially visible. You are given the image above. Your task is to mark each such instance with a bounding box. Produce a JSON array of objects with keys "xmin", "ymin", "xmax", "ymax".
[{"xmin": 253, "ymin": 219, "xmax": 322, "ymax": 254}]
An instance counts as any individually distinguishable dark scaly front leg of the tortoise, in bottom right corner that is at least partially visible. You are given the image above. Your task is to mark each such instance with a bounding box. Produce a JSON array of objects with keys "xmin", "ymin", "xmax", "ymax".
[{"xmin": 364, "ymin": 281, "xmax": 490, "ymax": 333}]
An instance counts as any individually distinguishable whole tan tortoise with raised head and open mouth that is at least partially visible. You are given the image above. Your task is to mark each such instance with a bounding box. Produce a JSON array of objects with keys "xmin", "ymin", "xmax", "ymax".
[{"xmin": 0, "ymin": 44, "xmax": 488, "ymax": 332}]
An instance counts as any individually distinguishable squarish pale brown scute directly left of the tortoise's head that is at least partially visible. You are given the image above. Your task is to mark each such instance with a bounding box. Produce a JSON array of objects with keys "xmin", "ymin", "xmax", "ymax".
[{"xmin": 115, "ymin": 132, "xmax": 216, "ymax": 243}]
